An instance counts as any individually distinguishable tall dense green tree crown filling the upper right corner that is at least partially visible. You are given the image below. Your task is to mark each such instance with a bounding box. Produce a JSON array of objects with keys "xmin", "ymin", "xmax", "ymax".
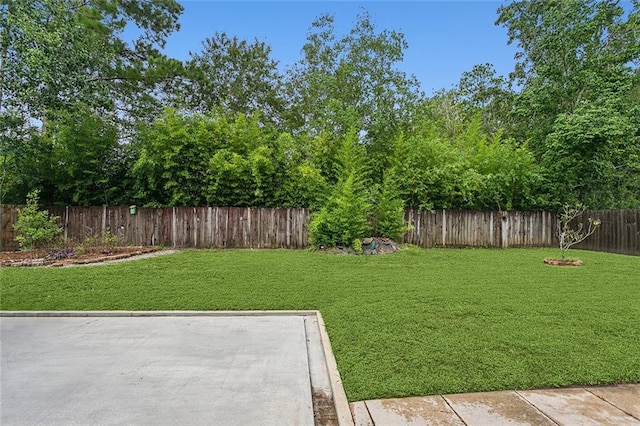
[{"xmin": 496, "ymin": 0, "xmax": 640, "ymax": 148}]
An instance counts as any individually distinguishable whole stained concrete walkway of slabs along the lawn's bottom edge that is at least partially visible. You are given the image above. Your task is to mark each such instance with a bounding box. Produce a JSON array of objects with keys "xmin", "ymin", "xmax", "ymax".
[{"xmin": 350, "ymin": 384, "xmax": 640, "ymax": 426}]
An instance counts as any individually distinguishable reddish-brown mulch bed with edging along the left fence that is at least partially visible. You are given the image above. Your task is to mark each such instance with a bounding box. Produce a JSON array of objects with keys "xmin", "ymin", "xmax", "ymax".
[{"xmin": 0, "ymin": 246, "xmax": 162, "ymax": 267}]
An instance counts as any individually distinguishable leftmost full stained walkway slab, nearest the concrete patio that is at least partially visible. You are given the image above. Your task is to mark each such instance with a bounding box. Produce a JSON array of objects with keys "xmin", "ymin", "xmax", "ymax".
[{"xmin": 365, "ymin": 396, "xmax": 464, "ymax": 426}]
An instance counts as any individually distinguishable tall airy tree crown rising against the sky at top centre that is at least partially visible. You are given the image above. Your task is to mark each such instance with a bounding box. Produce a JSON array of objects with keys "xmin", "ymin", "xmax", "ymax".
[{"xmin": 287, "ymin": 13, "xmax": 422, "ymax": 176}]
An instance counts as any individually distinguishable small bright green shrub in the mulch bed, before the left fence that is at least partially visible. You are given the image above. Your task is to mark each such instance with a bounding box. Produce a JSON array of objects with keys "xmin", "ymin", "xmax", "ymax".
[{"xmin": 13, "ymin": 191, "xmax": 62, "ymax": 251}]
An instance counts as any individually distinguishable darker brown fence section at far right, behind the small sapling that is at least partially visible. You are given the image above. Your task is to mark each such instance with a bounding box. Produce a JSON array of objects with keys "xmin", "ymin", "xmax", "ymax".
[{"xmin": 574, "ymin": 210, "xmax": 640, "ymax": 256}]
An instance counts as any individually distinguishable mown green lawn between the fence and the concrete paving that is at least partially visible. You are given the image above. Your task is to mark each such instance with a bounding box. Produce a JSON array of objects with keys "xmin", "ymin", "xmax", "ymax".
[{"xmin": 0, "ymin": 249, "xmax": 640, "ymax": 401}]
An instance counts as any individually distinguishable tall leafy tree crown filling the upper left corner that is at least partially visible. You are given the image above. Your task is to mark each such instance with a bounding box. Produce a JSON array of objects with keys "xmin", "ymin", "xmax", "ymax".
[{"xmin": 0, "ymin": 0, "xmax": 182, "ymax": 125}]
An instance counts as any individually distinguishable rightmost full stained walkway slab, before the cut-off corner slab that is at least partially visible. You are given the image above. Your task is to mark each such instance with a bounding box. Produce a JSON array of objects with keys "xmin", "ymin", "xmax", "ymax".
[{"xmin": 518, "ymin": 389, "xmax": 640, "ymax": 426}]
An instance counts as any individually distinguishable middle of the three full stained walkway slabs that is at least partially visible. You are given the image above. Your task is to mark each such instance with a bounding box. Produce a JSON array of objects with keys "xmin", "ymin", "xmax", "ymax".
[{"xmin": 444, "ymin": 392, "xmax": 555, "ymax": 426}]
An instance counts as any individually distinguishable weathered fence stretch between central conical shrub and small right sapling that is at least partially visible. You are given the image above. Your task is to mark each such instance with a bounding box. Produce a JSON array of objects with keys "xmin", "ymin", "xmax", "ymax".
[{"xmin": 402, "ymin": 210, "xmax": 556, "ymax": 247}]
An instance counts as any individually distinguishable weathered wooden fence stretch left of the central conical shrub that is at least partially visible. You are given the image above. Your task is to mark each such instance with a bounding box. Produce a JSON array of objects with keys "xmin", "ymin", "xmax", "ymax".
[{"xmin": 0, "ymin": 206, "xmax": 309, "ymax": 250}]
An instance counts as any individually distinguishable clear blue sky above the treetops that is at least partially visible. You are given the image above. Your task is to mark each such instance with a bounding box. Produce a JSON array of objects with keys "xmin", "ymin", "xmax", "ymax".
[{"xmin": 160, "ymin": 0, "xmax": 517, "ymax": 95}]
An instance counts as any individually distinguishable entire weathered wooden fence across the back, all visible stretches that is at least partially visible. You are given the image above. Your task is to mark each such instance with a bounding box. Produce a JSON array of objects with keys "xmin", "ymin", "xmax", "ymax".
[{"xmin": 0, "ymin": 205, "xmax": 640, "ymax": 255}]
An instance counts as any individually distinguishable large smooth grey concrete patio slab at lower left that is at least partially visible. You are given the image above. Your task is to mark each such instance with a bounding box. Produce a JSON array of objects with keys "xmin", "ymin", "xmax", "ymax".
[{"xmin": 0, "ymin": 313, "xmax": 350, "ymax": 425}]
